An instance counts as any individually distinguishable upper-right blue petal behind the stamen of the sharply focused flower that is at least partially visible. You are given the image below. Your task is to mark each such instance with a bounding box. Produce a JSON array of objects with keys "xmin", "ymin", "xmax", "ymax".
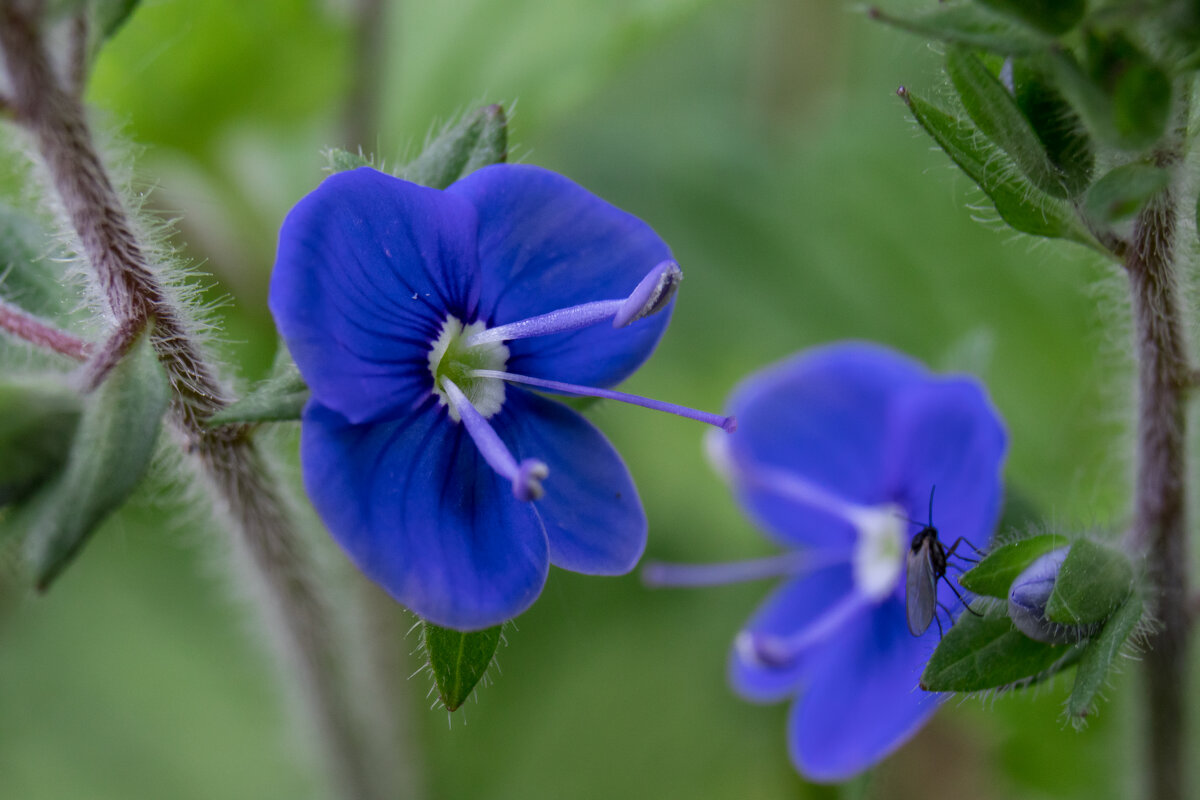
[{"xmin": 448, "ymin": 164, "xmax": 671, "ymax": 386}]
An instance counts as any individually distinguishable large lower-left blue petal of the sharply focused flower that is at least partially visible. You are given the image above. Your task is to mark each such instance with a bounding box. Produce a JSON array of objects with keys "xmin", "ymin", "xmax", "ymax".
[{"xmin": 300, "ymin": 402, "xmax": 548, "ymax": 630}]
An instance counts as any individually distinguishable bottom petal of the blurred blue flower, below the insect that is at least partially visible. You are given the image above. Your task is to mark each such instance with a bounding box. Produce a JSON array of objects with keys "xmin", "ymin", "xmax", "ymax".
[{"xmin": 787, "ymin": 599, "xmax": 941, "ymax": 782}]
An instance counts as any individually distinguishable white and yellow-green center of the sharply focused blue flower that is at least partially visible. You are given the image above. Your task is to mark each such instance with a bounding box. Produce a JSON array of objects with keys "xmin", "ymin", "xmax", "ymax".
[{"xmin": 430, "ymin": 317, "xmax": 509, "ymax": 422}]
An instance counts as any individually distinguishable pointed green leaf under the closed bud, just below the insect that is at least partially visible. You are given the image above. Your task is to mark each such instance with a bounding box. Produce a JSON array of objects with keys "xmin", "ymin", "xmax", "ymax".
[{"xmin": 920, "ymin": 603, "xmax": 1081, "ymax": 692}]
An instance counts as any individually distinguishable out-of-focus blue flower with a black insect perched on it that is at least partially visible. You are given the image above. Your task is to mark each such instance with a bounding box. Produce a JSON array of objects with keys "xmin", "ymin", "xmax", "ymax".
[{"xmin": 646, "ymin": 344, "xmax": 1007, "ymax": 782}]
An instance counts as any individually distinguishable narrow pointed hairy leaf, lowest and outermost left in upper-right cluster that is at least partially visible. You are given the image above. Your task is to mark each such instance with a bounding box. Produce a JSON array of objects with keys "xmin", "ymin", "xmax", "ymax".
[{"xmin": 899, "ymin": 88, "xmax": 1103, "ymax": 251}]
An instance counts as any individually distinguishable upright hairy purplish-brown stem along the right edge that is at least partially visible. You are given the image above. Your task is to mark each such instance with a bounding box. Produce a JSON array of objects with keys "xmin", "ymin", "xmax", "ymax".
[{"xmin": 1124, "ymin": 165, "xmax": 1193, "ymax": 800}]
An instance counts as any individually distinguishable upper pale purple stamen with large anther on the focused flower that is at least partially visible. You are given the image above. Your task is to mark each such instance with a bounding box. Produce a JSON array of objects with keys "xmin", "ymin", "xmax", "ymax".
[{"xmin": 467, "ymin": 260, "xmax": 683, "ymax": 347}]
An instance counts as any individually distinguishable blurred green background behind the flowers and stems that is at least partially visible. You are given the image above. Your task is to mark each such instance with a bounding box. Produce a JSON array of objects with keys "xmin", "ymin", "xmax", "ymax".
[{"xmin": 0, "ymin": 0, "xmax": 1161, "ymax": 800}]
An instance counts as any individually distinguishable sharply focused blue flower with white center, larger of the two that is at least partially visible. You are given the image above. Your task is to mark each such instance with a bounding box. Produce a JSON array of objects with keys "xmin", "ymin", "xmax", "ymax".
[{"xmin": 270, "ymin": 164, "xmax": 726, "ymax": 630}]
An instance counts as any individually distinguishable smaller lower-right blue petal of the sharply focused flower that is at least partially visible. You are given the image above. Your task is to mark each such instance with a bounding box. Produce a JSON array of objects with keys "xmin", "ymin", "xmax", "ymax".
[{"xmin": 492, "ymin": 386, "xmax": 646, "ymax": 575}]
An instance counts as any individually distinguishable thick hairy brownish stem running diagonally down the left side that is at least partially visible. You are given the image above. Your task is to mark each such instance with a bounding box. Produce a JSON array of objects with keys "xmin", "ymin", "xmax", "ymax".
[{"xmin": 0, "ymin": 0, "xmax": 390, "ymax": 799}]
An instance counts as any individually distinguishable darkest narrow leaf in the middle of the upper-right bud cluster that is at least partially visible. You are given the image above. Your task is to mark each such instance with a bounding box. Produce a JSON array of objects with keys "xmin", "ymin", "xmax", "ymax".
[{"xmin": 1009, "ymin": 59, "xmax": 1096, "ymax": 197}]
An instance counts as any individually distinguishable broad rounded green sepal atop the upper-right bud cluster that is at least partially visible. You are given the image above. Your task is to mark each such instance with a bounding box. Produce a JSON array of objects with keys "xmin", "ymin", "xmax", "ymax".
[{"xmin": 1050, "ymin": 46, "xmax": 1171, "ymax": 151}]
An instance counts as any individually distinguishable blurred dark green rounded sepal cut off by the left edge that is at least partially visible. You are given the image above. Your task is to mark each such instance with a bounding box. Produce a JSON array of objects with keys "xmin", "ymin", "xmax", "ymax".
[{"xmin": 0, "ymin": 375, "xmax": 82, "ymax": 506}]
